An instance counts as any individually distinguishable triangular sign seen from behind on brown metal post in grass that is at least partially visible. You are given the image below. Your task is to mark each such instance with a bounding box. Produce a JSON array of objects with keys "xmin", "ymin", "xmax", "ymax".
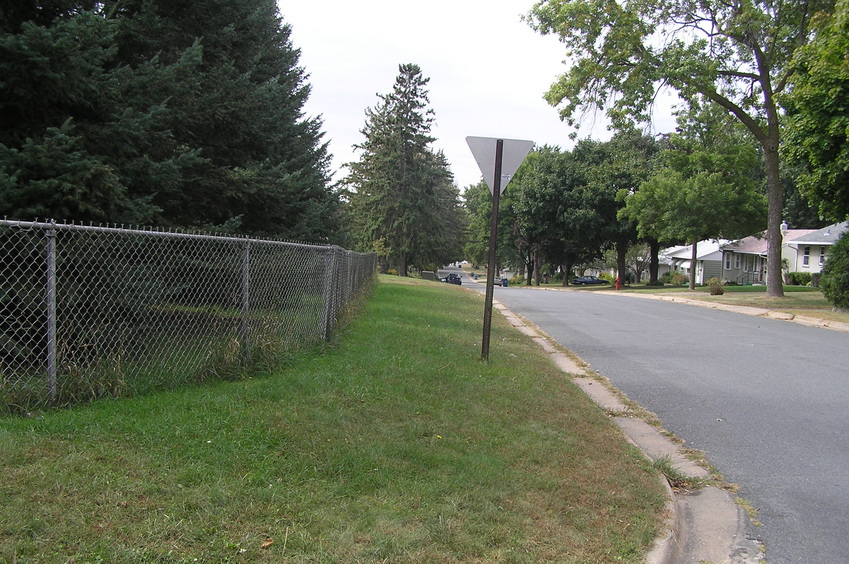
[{"xmin": 466, "ymin": 137, "xmax": 534, "ymax": 360}]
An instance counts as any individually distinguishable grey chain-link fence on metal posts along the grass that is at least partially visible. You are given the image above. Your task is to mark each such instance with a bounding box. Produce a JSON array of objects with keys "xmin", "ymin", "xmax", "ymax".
[{"xmin": 0, "ymin": 220, "xmax": 377, "ymax": 413}]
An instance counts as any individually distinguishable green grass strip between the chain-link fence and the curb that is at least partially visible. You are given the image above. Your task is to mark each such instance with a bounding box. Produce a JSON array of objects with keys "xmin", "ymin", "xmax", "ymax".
[{"xmin": 0, "ymin": 277, "xmax": 665, "ymax": 563}]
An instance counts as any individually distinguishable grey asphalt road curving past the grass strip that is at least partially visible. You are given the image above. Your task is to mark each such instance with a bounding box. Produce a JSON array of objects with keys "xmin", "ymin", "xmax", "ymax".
[{"xmin": 463, "ymin": 279, "xmax": 849, "ymax": 564}]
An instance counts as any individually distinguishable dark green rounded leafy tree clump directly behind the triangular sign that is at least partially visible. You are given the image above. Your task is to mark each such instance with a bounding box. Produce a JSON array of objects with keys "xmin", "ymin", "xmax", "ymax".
[{"xmin": 466, "ymin": 129, "xmax": 657, "ymax": 284}]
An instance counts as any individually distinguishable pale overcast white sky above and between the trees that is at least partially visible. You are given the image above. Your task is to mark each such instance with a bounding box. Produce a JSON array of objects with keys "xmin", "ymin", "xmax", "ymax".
[{"xmin": 278, "ymin": 0, "xmax": 672, "ymax": 191}]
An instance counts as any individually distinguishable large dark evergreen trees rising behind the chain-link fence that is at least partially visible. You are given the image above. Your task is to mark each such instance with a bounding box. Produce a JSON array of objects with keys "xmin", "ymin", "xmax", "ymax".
[{"xmin": 0, "ymin": 0, "xmax": 339, "ymax": 241}]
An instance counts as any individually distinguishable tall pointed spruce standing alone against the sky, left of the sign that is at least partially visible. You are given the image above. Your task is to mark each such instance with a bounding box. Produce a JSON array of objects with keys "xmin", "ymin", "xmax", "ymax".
[{"xmin": 346, "ymin": 64, "xmax": 464, "ymax": 276}]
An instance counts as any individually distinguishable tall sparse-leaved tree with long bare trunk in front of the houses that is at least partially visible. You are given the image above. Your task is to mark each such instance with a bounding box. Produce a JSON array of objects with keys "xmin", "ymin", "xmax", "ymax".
[{"xmin": 529, "ymin": 0, "xmax": 830, "ymax": 296}]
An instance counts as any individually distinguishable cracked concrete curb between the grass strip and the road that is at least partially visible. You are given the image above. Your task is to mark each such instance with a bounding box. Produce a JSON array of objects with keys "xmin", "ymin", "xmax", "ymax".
[{"xmin": 493, "ymin": 300, "xmax": 765, "ymax": 564}]
